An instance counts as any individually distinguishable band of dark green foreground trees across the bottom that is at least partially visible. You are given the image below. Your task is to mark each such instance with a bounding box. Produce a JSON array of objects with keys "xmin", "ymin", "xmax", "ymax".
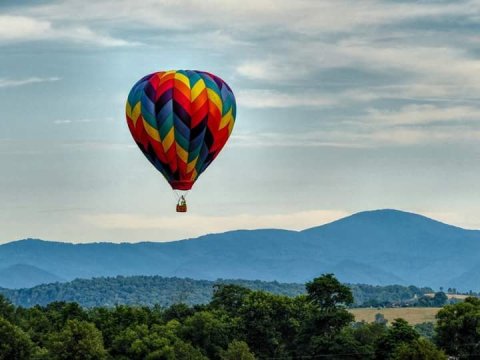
[{"xmin": 0, "ymin": 275, "xmax": 480, "ymax": 360}]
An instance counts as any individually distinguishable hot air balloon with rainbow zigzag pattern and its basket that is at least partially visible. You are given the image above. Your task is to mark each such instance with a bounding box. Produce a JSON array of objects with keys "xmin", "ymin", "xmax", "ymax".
[{"xmin": 126, "ymin": 70, "xmax": 236, "ymax": 212}]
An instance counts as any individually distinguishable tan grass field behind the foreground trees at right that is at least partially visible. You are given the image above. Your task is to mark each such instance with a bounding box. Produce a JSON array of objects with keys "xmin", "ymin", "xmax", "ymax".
[{"xmin": 350, "ymin": 308, "xmax": 441, "ymax": 325}]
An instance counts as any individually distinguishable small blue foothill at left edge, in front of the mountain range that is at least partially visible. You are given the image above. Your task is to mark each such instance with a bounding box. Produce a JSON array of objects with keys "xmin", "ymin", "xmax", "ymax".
[{"xmin": 0, "ymin": 264, "xmax": 65, "ymax": 288}]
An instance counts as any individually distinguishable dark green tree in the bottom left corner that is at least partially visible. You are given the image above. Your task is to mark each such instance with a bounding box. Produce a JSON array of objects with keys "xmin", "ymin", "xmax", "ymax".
[{"xmin": 0, "ymin": 317, "xmax": 33, "ymax": 360}]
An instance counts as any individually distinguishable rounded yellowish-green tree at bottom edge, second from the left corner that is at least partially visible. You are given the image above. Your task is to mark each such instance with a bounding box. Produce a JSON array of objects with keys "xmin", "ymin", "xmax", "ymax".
[{"xmin": 48, "ymin": 320, "xmax": 107, "ymax": 360}]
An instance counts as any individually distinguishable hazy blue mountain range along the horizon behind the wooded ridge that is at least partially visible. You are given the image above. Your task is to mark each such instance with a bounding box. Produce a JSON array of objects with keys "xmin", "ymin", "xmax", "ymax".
[{"xmin": 0, "ymin": 210, "xmax": 480, "ymax": 291}]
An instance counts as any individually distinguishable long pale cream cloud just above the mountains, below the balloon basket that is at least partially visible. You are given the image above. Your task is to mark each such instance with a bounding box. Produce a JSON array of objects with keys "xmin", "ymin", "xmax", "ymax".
[{"xmin": 79, "ymin": 210, "xmax": 349, "ymax": 236}]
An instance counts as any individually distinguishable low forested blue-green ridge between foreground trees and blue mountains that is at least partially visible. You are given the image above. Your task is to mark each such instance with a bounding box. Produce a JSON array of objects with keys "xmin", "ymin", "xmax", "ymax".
[{"xmin": 0, "ymin": 276, "xmax": 433, "ymax": 308}]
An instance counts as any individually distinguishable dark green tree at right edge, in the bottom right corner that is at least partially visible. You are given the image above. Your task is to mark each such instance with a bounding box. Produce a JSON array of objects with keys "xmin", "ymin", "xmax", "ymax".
[{"xmin": 436, "ymin": 297, "xmax": 480, "ymax": 359}]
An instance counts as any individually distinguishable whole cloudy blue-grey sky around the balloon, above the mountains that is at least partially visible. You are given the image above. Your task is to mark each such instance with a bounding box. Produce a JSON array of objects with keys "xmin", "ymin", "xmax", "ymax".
[{"xmin": 0, "ymin": 0, "xmax": 480, "ymax": 243}]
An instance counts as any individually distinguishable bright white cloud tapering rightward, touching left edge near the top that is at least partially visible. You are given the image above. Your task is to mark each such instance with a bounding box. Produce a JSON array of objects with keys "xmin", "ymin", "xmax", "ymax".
[{"xmin": 0, "ymin": 15, "xmax": 139, "ymax": 47}]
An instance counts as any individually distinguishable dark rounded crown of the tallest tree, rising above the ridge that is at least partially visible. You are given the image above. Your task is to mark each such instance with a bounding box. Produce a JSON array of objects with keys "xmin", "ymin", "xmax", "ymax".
[{"xmin": 306, "ymin": 274, "xmax": 353, "ymax": 311}]
